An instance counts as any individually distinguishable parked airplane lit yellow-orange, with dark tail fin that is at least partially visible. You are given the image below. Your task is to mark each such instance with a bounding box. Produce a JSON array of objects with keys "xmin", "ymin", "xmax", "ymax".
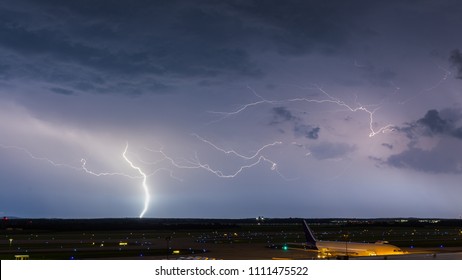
[{"xmin": 303, "ymin": 220, "xmax": 406, "ymax": 259}]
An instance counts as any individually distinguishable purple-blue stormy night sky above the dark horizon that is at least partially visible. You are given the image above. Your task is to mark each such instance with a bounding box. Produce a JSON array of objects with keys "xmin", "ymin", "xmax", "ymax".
[{"xmin": 0, "ymin": 0, "xmax": 462, "ymax": 218}]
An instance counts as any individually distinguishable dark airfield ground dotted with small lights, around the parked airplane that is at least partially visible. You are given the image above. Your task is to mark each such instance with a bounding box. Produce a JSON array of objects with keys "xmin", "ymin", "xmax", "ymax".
[{"xmin": 0, "ymin": 218, "xmax": 462, "ymax": 260}]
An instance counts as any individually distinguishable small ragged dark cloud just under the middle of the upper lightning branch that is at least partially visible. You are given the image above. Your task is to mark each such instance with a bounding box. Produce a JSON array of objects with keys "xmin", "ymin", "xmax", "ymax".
[{"xmin": 270, "ymin": 107, "xmax": 321, "ymax": 140}]
